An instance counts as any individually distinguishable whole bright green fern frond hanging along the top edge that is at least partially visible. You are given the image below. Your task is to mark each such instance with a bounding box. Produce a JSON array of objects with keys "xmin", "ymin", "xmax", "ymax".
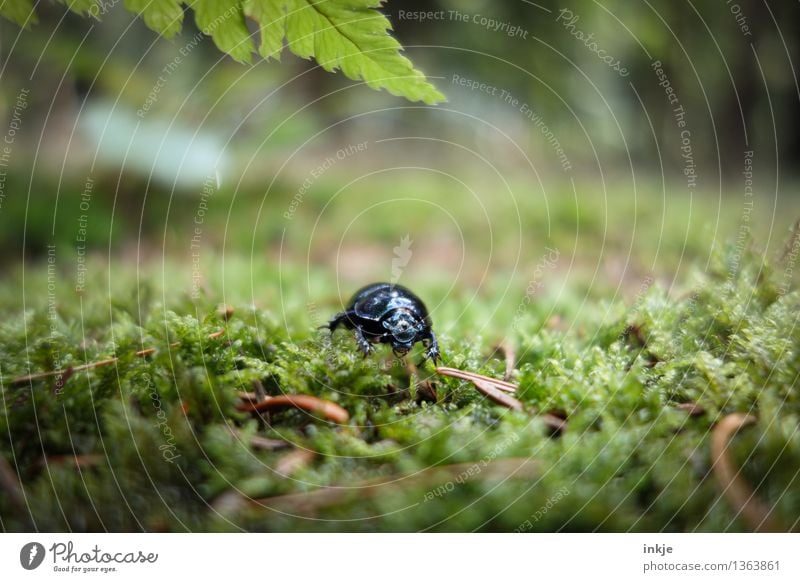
[{"xmin": 0, "ymin": 0, "xmax": 445, "ymax": 104}]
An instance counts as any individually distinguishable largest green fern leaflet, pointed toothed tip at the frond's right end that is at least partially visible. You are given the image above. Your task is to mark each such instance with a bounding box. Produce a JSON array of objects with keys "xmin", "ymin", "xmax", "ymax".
[{"xmin": 286, "ymin": 0, "xmax": 445, "ymax": 104}]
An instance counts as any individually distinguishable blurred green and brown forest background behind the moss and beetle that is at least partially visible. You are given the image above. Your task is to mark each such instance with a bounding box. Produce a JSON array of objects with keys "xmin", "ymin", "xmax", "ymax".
[{"xmin": 0, "ymin": 1, "xmax": 800, "ymax": 303}]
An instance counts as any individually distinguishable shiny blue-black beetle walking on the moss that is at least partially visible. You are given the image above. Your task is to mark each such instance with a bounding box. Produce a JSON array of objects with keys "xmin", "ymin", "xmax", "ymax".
[{"xmin": 322, "ymin": 283, "xmax": 439, "ymax": 364}]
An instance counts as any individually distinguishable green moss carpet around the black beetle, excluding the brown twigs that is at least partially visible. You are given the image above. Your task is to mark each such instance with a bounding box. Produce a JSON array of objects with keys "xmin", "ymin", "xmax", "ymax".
[{"xmin": 0, "ymin": 196, "xmax": 800, "ymax": 531}]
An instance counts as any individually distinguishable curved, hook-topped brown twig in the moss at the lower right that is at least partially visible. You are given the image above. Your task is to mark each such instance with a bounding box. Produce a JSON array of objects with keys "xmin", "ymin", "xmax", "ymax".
[{"xmin": 711, "ymin": 413, "xmax": 783, "ymax": 532}]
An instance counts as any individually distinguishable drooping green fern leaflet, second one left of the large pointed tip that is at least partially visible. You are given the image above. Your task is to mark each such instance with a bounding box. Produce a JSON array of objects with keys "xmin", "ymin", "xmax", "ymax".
[{"xmin": 192, "ymin": 0, "xmax": 255, "ymax": 63}]
